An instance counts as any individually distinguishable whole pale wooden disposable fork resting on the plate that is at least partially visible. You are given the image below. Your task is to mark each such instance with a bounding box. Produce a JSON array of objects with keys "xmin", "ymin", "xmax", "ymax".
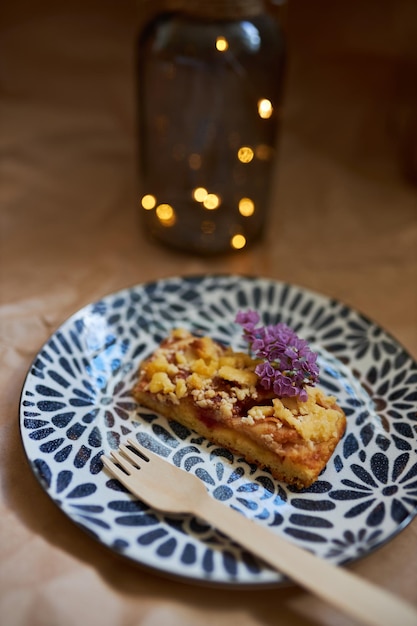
[{"xmin": 101, "ymin": 439, "xmax": 417, "ymax": 626}]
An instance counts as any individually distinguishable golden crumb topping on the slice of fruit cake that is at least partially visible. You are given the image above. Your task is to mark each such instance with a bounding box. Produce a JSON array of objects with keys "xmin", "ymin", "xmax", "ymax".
[{"xmin": 138, "ymin": 329, "xmax": 341, "ymax": 442}]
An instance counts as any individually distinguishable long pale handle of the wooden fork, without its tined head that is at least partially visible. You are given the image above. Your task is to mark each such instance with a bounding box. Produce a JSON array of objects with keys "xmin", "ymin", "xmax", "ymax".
[{"xmin": 195, "ymin": 497, "xmax": 417, "ymax": 626}]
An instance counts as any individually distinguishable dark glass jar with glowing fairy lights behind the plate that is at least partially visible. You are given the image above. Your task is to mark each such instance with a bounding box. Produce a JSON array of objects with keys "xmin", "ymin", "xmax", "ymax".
[{"xmin": 138, "ymin": 0, "xmax": 285, "ymax": 254}]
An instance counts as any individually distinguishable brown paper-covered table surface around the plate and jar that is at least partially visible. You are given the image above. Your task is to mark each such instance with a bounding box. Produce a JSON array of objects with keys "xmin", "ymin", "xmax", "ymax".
[{"xmin": 0, "ymin": 0, "xmax": 417, "ymax": 626}]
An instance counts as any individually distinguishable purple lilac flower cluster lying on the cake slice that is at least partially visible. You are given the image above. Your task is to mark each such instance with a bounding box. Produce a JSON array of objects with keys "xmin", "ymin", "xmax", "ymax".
[{"xmin": 236, "ymin": 310, "xmax": 319, "ymax": 401}]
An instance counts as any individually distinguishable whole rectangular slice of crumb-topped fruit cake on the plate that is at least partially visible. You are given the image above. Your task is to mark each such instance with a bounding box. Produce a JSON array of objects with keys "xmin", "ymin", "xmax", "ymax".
[{"xmin": 133, "ymin": 329, "xmax": 346, "ymax": 488}]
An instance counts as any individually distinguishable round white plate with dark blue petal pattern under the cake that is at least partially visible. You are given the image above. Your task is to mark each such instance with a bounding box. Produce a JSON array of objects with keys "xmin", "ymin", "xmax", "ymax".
[{"xmin": 20, "ymin": 275, "xmax": 417, "ymax": 586}]
